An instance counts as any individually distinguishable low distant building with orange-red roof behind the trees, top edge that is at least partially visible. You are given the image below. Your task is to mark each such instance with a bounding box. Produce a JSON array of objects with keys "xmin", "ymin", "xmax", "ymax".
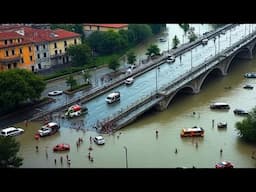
[{"xmin": 83, "ymin": 23, "xmax": 128, "ymax": 32}]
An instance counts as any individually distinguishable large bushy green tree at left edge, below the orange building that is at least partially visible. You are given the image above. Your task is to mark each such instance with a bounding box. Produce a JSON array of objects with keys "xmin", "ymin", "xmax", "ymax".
[{"xmin": 0, "ymin": 69, "xmax": 46, "ymax": 111}]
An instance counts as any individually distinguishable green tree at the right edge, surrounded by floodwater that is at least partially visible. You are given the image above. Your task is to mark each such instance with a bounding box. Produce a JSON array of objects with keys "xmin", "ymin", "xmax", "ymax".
[{"xmin": 235, "ymin": 107, "xmax": 256, "ymax": 142}]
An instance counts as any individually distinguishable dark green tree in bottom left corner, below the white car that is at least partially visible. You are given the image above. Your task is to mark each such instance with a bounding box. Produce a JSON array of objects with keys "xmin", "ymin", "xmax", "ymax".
[{"xmin": 0, "ymin": 137, "xmax": 23, "ymax": 168}]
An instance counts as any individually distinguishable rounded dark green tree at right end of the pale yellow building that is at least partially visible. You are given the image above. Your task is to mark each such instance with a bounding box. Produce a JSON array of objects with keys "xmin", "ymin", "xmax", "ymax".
[{"xmin": 67, "ymin": 43, "xmax": 92, "ymax": 66}]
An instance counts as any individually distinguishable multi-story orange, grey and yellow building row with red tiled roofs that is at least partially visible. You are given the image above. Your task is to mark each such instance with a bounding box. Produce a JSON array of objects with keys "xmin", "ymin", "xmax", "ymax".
[{"xmin": 0, "ymin": 26, "xmax": 81, "ymax": 71}]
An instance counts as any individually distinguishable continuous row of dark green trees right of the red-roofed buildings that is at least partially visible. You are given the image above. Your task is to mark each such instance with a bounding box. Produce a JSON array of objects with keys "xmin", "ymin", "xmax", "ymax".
[{"xmin": 65, "ymin": 24, "xmax": 166, "ymax": 67}]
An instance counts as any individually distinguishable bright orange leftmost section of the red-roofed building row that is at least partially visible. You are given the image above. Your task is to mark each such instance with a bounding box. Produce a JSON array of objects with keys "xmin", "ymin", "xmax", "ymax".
[{"xmin": 0, "ymin": 30, "xmax": 35, "ymax": 71}]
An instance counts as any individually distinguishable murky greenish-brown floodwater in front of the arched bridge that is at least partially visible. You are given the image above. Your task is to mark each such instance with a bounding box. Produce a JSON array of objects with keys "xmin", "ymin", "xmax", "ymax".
[{"xmin": 16, "ymin": 54, "xmax": 256, "ymax": 168}]
